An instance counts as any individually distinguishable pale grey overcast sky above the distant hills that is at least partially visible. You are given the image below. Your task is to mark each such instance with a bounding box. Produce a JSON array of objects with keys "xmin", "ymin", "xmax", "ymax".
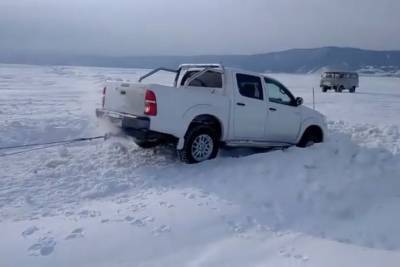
[{"xmin": 0, "ymin": 0, "xmax": 400, "ymax": 56}]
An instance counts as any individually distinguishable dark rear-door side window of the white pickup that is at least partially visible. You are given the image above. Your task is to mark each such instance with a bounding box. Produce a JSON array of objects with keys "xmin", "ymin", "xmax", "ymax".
[{"xmin": 236, "ymin": 74, "xmax": 264, "ymax": 100}]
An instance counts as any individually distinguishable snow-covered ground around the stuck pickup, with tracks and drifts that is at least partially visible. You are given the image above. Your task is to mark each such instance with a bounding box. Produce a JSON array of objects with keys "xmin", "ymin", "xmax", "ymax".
[{"xmin": 0, "ymin": 65, "xmax": 400, "ymax": 267}]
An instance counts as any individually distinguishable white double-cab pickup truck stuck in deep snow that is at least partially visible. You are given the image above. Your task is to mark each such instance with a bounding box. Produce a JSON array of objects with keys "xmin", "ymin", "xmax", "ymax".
[{"xmin": 96, "ymin": 64, "xmax": 326, "ymax": 163}]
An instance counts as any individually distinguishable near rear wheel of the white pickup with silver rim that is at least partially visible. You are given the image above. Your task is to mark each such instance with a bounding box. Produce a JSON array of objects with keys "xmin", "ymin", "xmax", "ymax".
[{"xmin": 178, "ymin": 125, "xmax": 219, "ymax": 164}]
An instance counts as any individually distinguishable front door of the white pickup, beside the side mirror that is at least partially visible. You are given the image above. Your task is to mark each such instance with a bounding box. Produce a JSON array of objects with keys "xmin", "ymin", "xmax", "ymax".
[{"xmin": 264, "ymin": 78, "xmax": 301, "ymax": 144}]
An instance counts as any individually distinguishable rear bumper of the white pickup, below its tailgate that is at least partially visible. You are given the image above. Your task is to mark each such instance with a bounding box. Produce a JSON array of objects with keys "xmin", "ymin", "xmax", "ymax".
[{"xmin": 96, "ymin": 109, "xmax": 170, "ymax": 141}]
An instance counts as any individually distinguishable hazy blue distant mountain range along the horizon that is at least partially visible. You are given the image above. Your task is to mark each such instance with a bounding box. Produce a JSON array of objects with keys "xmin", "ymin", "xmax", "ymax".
[{"xmin": 0, "ymin": 47, "xmax": 400, "ymax": 76}]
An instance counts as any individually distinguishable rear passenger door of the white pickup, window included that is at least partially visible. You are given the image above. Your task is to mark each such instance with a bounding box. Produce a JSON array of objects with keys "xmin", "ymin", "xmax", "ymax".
[{"xmin": 233, "ymin": 73, "xmax": 267, "ymax": 140}]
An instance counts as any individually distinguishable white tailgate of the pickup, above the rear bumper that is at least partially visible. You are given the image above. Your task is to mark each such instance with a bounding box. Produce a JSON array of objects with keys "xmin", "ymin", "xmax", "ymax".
[{"xmin": 104, "ymin": 82, "xmax": 146, "ymax": 115}]
